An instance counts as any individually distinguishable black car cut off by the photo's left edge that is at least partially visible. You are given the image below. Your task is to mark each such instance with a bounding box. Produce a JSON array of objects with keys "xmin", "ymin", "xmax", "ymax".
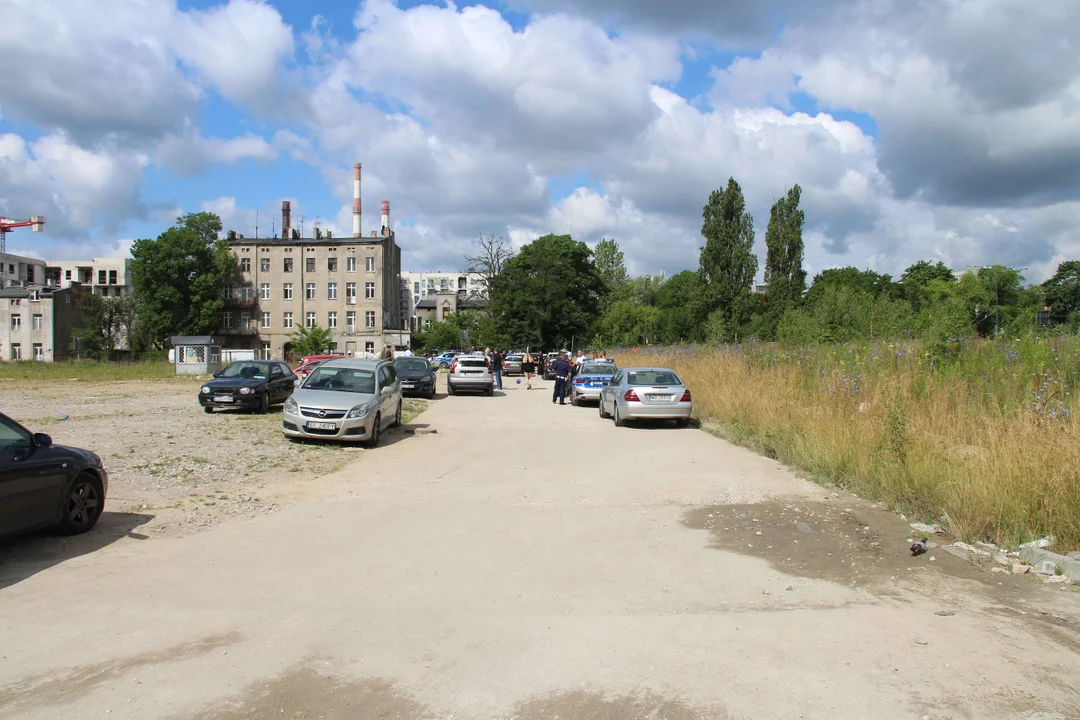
[{"xmin": 0, "ymin": 412, "xmax": 109, "ymax": 538}]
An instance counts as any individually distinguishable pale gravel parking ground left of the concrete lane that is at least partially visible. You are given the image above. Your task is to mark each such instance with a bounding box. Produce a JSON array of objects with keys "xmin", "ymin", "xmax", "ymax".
[{"xmin": 0, "ymin": 378, "xmax": 427, "ymax": 535}]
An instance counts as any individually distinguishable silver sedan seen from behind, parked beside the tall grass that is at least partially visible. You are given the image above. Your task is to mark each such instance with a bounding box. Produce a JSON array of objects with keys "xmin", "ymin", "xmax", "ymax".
[{"xmin": 599, "ymin": 367, "xmax": 693, "ymax": 427}]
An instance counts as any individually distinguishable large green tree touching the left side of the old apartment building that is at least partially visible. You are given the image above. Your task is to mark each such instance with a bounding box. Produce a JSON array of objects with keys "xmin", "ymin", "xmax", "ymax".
[{"xmin": 132, "ymin": 213, "xmax": 237, "ymax": 348}]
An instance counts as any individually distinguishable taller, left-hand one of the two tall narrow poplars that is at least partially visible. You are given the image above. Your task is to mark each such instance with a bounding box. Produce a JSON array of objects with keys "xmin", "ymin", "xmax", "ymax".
[{"xmin": 699, "ymin": 178, "xmax": 757, "ymax": 337}]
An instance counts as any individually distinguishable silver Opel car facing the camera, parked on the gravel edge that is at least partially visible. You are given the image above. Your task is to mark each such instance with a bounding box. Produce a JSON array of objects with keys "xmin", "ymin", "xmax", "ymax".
[{"xmin": 281, "ymin": 359, "xmax": 402, "ymax": 448}]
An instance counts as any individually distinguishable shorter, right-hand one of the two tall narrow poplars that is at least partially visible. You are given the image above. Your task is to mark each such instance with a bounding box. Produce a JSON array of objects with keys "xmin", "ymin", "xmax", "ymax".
[{"xmin": 765, "ymin": 185, "xmax": 807, "ymax": 317}]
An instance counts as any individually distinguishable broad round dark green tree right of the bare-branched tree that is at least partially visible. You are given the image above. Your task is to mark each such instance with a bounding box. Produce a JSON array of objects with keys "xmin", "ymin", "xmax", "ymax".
[{"xmin": 490, "ymin": 235, "xmax": 607, "ymax": 348}]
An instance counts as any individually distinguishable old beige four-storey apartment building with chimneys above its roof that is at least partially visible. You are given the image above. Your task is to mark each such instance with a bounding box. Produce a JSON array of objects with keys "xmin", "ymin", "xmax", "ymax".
[{"xmin": 220, "ymin": 164, "xmax": 409, "ymax": 359}]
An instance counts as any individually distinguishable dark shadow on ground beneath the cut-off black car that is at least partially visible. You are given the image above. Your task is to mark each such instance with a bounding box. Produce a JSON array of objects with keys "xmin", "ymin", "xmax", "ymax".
[{"xmin": 0, "ymin": 511, "xmax": 154, "ymax": 589}]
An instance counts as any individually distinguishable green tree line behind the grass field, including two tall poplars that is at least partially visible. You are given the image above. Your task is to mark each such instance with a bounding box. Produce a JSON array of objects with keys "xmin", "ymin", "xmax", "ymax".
[{"xmin": 418, "ymin": 178, "xmax": 1080, "ymax": 352}]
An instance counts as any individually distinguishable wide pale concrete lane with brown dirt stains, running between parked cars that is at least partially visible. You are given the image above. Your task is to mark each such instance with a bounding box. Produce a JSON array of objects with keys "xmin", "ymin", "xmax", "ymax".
[{"xmin": 0, "ymin": 383, "xmax": 1080, "ymax": 720}]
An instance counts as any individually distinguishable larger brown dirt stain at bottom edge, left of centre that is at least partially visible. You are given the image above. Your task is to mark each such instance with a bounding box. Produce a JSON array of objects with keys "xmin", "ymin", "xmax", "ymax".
[{"xmin": 183, "ymin": 666, "xmax": 429, "ymax": 720}]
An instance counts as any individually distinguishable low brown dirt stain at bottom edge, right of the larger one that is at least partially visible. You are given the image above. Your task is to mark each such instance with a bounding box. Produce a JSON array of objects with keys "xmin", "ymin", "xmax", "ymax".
[{"xmin": 511, "ymin": 691, "xmax": 728, "ymax": 720}]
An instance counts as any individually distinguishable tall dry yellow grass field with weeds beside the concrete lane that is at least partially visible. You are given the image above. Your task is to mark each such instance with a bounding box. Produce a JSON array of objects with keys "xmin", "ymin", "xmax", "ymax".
[{"xmin": 615, "ymin": 339, "xmax": 1080, "ymax": 549}]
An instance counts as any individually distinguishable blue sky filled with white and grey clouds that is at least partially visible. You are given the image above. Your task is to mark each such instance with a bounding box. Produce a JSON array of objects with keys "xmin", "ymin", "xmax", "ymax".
[{"xmin": 0, "ymin": 0, "xmax": 1080, "ymax": 282}]
